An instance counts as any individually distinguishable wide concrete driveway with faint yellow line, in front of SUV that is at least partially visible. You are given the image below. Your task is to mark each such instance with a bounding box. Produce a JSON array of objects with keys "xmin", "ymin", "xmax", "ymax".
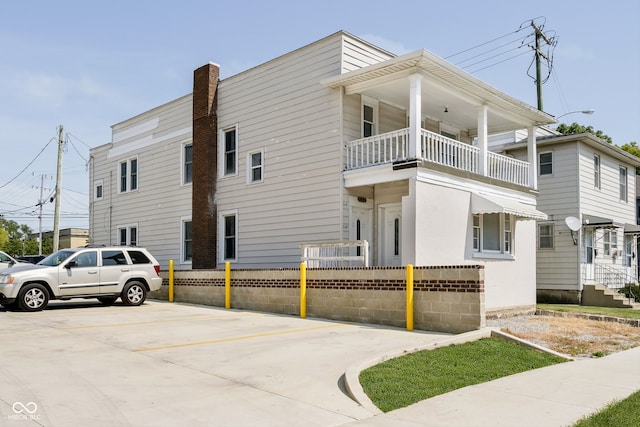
[{"xmin": 0, "ymin": 300, "xmax": 449, "ymax": 427}]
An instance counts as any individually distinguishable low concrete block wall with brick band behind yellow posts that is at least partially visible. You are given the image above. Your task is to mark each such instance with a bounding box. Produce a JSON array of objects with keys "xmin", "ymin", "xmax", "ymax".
[{"xmin": 149, "ymin": 265, "xmax": 485, "ymax": 333}]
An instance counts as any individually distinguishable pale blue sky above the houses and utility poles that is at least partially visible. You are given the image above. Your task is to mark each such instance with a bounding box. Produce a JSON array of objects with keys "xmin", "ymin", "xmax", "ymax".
[{"xmin": 0, "ymin": 0, "xmax": 640, "ymax": 231}]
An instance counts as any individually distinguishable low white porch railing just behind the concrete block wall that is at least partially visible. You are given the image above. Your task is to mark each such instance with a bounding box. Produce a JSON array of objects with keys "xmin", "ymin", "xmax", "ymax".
[{"xmin": 300, "ymin": 240, "xmax": 369, "ymax": 268}]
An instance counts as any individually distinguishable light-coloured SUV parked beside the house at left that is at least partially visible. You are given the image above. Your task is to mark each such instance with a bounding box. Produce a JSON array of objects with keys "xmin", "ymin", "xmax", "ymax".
[{"xmin": 0, "ymin": 246, "xmax": 162, "ymax": 311}]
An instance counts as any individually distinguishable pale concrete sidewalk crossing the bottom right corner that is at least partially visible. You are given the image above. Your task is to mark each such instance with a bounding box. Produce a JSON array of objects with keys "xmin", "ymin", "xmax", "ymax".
[{"xmin": 349, "ymin": 347, "xmax": 640, "ymax": 427}]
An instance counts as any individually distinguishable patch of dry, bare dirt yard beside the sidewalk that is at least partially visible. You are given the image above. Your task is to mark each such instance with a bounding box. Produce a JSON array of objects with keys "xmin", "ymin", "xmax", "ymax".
[{"xmin": 487, "ymin": 315, "xmax": 640, "ymax": 357}]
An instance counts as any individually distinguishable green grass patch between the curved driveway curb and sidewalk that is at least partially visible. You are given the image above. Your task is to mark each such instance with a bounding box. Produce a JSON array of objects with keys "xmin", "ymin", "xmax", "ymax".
[{"xmin": 360, "ymin": 338, "xmax": 565, "ymax": 412}]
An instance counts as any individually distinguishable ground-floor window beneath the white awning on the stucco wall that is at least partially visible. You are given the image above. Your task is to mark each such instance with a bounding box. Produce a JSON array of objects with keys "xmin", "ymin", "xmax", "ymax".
[{"xmin": 473, "ymin": 213, "xmax": 513, "ymax": 254}]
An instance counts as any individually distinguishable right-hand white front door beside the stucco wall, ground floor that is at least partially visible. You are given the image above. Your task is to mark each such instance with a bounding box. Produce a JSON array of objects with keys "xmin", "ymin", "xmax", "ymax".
[{"xmin": 378, "ymin": 203, "xmax": 402, "ymax": 266}]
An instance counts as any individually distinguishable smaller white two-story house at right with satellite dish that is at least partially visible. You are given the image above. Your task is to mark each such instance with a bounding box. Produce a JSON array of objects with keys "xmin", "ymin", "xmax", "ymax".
[{"xmin": 503, "ymin": 132, "xmax": 640, "ymax": 305}]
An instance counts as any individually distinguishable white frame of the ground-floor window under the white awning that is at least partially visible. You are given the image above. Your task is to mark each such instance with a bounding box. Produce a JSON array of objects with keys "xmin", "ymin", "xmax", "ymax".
[{"xmin": 472, "ymin": 212, "xmax": 516, "ymax": 259}]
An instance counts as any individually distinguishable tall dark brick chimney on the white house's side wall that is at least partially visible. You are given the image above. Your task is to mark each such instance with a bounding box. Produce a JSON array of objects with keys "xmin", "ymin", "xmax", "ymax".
[{"xmin": 191, "ymin": 63, "xmax": 220, "ymax": 269}]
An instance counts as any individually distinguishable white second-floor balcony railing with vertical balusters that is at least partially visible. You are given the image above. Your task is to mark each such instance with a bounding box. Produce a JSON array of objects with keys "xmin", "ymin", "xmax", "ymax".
[{"xmin": 346, "ymin": 128, "xmax": 529, "ymax": 186}]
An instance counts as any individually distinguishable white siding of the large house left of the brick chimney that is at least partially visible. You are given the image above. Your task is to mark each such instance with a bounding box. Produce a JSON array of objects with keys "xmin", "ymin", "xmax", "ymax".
[{"xmin": 90, "ymin": 95, "xmax": 192, "ymax": 269}]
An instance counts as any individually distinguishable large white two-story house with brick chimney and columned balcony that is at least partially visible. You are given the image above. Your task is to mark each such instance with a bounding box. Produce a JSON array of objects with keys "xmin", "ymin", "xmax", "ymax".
[{"xmin": 90, "ymin": 32, "xmax": 555, "ymax": 311}]
